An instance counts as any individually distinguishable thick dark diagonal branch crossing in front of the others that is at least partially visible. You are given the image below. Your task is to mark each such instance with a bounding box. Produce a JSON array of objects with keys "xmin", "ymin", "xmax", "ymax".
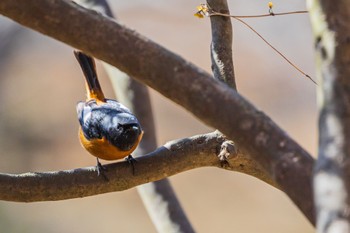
[{"xmin": 0, "ymin": 0, "xmax": 314, "ymax": 225}]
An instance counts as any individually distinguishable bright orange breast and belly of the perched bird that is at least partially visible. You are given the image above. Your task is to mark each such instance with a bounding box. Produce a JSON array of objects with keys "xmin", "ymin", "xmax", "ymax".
[{"xmin": 79, "ymin": 128, "xmax": 143, "ymax": 160}]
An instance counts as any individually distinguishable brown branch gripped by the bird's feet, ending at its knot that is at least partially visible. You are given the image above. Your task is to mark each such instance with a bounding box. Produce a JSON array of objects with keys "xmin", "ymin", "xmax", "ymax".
[{"xmin": 0, "ymin": 132, "xmax": 234, "ymax": 202}]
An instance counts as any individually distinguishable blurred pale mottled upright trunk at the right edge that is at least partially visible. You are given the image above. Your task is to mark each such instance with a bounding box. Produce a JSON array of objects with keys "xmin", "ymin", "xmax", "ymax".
[{"xmin": 309, "ymin": 0, "xmax": 350, "ymax": 233}]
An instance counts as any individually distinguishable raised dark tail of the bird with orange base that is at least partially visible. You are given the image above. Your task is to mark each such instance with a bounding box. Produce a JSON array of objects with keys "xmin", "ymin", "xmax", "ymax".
[{"xmin": 74, "ymin": 51, "xmax": 105, "ymax": 102}]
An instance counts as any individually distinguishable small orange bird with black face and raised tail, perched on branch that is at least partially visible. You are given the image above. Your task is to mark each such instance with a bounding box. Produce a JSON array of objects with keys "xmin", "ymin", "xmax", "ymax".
[{"xmin": 74, "ymin": 51, "xmax": 143, "ymax": 175}]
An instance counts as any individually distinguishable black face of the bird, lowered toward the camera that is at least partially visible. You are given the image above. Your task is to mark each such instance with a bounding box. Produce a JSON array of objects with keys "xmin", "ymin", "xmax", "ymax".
[{"xmin": 107, "ymin": 124, "xmax": 142, "ymax": 151}]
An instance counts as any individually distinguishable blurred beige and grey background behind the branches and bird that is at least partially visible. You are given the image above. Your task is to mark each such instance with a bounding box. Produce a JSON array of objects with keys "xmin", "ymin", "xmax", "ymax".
[{"xmin": 0, "ymin": 0, "xmax": 317, "ymax": 233}]
